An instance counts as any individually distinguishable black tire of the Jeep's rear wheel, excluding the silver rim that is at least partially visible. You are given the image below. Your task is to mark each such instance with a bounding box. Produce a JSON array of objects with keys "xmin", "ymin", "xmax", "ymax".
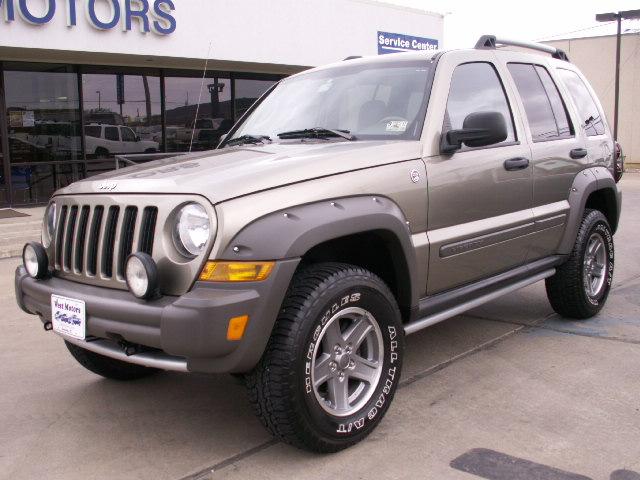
[{"xmin": 546, "ymin": 210, "xmax": 615, "ymax": 320}]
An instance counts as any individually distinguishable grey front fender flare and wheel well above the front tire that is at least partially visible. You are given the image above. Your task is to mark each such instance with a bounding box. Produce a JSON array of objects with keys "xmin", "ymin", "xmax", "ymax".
[{"xmin": 221, "ymin": 195, "xmax": 419, "ymax": 317}]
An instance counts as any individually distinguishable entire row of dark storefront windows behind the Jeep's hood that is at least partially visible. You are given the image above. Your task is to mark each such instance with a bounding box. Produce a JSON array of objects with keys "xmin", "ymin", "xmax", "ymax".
[{"xmin": 0, "ymin": 62, "xmax": 284, "ymax": 205}]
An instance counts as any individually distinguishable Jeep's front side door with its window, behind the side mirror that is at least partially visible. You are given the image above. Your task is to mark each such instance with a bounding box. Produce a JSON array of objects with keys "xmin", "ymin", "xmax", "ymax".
[{"xmin": 425, "ymin": 56, "xmax": 533, "ymax": 295}]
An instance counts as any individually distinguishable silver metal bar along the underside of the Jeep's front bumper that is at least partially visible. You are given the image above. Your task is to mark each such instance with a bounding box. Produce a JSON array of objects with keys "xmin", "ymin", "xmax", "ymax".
[{"xmin": 60, "ymin": 335, "xmax": 189, "ymax": 372}]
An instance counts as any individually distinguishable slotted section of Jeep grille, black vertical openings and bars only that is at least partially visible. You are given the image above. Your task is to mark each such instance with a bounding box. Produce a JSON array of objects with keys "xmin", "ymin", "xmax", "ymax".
[{"xmin": 54, "ymin": 202, "xmax": 158, "ymax": 282}]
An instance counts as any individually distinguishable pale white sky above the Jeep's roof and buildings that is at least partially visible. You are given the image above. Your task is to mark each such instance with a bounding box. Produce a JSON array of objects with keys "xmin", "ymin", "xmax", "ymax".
[{"xmin": 382, "ymin": 0, "xmax": 640, "ymax": 48}]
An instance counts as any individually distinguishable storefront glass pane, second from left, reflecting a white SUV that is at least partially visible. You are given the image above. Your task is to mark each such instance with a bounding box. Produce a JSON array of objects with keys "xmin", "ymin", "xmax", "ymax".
[{"xmin": 82, "ymin": 73, "xmax": 162, "ymax": 176}]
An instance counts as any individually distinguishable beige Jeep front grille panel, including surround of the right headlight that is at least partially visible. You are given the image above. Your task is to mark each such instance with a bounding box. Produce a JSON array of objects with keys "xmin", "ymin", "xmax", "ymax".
[{"xmin": 47, "ymin": 193, "xmax": 215, "ymax": 295}]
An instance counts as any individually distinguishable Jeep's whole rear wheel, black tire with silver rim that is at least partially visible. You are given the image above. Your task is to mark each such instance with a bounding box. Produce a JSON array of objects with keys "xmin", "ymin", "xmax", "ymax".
[{"xmin": 546, "ymin": 210, "xmax": 615, "ymax": 319}]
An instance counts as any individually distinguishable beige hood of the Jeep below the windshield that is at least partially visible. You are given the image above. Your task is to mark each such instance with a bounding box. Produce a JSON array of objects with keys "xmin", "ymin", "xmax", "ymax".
[{"xmin": 56, "ymin": 141, "xmax": 421, "ymax": 204}]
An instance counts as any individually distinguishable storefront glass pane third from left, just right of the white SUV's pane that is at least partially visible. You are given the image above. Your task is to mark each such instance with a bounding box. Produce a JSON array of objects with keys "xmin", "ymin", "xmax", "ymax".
[{"xmin": 164, "ymin": 77, "xmax": 233, "ymax": 152}]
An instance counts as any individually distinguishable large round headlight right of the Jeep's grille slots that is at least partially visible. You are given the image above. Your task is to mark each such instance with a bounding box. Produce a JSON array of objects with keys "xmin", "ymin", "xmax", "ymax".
[{"xmin": 174, "ymin": 203, "xmax": 211, "ymax": 257}]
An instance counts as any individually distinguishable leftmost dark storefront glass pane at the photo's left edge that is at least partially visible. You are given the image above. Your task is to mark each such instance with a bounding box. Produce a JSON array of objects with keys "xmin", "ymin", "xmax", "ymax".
[{"xmin": 4, "ymin": 64, "xmax": 82, "ymax": 204}]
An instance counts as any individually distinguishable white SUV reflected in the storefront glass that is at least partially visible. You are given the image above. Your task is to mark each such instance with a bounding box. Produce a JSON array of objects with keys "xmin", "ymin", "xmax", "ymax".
[{"xmin": 84, "ymin": 123, "xmax": 159, "ymax": 157}]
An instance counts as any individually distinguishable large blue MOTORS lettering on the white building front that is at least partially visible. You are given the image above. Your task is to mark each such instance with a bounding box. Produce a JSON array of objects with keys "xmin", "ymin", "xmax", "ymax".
[{"xmin": 0, "ymin": 0, "xmax": 176, "ymax": 35}]
